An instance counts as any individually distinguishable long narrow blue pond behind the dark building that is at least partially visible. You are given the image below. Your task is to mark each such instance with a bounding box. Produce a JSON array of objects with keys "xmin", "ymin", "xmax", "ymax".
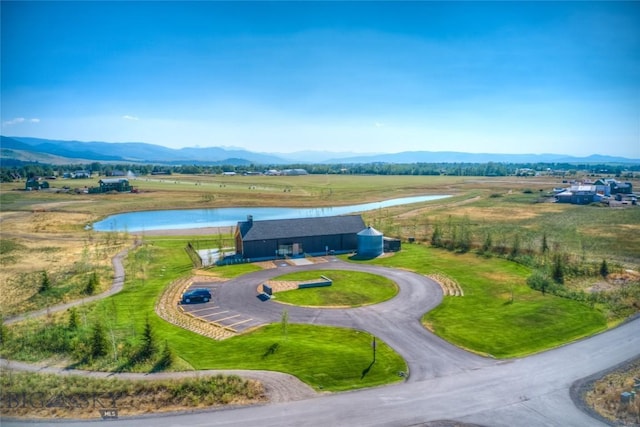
[{"xmin": 93, "ymin": 195, "xmax": 451, "ymax": 232}]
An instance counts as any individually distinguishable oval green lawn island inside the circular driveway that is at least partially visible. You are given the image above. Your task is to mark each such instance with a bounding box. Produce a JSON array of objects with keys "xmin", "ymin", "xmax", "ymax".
[{"xmin": 271, "ymin": 270, "xmax": 398, "ymax": 307}]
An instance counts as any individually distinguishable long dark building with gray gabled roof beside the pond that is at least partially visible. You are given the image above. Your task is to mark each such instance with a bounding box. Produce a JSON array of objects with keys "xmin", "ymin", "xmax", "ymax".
[{"xmin": 235, "ymin": 215, "xmax": 366, "ymax": 260}]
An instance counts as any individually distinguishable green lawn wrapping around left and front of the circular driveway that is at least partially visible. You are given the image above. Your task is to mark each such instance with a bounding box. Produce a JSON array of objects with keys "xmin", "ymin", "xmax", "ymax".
[{"xmin": 0, "ymin": 238, "xmax": 407, "ymax": 391}]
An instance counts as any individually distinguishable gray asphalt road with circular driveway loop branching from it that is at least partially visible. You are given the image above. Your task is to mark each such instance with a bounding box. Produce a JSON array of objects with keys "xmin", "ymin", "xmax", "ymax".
[{"xmin": 2, "ymin": 261, "xmax": 640, "ymax": 427}]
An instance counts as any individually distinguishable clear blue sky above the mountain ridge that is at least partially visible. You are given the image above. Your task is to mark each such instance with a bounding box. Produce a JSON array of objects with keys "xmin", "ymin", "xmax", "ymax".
[{"xmin": 0, "ymin": 1, "xmax": 640, "ymax": 158}]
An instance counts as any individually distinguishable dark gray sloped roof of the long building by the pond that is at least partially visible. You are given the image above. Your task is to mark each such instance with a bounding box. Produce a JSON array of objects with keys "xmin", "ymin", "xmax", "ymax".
[{"xmin": 238, "ymin": 215, "xmax": 365, "ymax": 241}]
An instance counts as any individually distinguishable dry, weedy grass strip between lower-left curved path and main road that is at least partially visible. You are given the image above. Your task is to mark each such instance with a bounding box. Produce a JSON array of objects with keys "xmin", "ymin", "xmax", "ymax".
[{"xmin": 0, "ymin": 370, "xmax": 265, "ymax": 419}]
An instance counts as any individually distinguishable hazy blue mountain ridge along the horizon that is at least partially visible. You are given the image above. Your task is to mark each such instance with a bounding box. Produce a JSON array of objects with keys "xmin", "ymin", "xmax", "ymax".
[{"xmin": 0, "ymin": 136, "xmax": 640, "ymax": 166}]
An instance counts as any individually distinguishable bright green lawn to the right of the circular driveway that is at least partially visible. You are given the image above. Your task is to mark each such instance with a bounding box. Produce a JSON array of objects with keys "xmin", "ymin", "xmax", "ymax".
[{"xmin": 356, "ymin": 245, "xmax": 607, "ymax": 358}]
